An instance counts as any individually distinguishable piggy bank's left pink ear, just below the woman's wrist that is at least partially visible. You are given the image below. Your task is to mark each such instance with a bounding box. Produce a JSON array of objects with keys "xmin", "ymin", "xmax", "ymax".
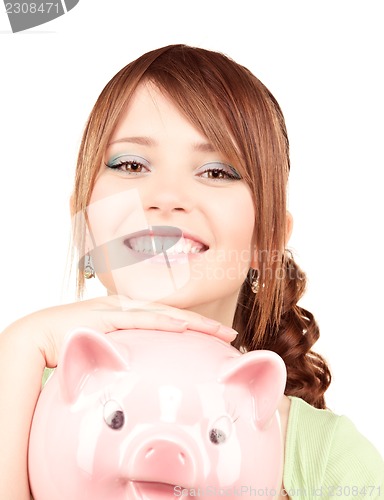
[{"xmin": 57, "ymin": 328, "xmax": 129, "ymax": 404}]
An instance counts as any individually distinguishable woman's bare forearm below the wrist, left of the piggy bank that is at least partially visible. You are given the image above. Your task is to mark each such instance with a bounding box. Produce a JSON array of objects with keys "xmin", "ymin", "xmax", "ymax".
[{"xmin": 0, "ymin": 322, "xmax": 45, "ymax": 500}]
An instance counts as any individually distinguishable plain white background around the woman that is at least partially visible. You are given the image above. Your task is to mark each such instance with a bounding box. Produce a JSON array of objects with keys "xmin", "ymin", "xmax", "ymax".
[{"xmin": 0, "ymin": 0, "xmax": 384, "ymax": 455}]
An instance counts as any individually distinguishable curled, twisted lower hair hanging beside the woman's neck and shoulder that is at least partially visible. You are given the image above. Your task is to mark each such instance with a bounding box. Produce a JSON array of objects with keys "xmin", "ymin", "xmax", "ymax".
[{"xmin": 233, "ymin": 252, "xmax": 331, "ymax": 408}]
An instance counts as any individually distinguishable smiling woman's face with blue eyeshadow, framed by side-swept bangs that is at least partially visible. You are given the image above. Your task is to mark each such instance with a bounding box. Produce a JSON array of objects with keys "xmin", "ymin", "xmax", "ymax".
[{"xmin": 87, "ymin": 83, "xmax": 255, "ymax": 321}]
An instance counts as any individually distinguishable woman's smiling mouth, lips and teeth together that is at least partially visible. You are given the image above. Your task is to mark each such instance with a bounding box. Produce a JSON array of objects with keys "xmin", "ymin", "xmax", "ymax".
[{"xmin": 124, "ymin": 226, "xmax": 209, "ymax": 256}]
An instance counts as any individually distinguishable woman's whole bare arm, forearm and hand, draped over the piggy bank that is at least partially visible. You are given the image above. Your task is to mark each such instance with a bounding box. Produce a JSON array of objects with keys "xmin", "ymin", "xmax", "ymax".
[{"xmin": 0, "ymin": 296, "xmax": 235, "ymax": 500}]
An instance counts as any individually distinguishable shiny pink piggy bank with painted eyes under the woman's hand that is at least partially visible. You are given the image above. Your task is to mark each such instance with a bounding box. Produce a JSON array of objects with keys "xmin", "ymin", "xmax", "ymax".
[{"xmin": 29, "ymin": 329, "xmax": 286, "ymax": 500}]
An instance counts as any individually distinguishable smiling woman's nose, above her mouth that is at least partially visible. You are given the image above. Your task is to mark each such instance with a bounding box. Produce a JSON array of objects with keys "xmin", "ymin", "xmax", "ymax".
[{"xmin": 140, "ymin": 176, "xmax": 192, "ymax": 215}]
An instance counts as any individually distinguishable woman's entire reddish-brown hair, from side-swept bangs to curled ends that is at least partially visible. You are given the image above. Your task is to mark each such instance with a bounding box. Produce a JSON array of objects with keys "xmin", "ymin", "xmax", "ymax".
[{"xmin": 73, "ymin": 45, "xmax": 331, "ymax": 408}]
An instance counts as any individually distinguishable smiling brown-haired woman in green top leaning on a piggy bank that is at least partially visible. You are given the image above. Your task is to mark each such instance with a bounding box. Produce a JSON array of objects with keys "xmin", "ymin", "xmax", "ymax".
[{"xmin": 0, "ymin": 45, "xmax": 384, "ymax": 500}]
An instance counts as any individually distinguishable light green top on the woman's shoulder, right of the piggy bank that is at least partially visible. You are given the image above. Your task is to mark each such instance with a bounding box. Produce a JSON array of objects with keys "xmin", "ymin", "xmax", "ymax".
[{"xmin": 284, "ymin": 397, "xmax": 384, "ymax": 500}]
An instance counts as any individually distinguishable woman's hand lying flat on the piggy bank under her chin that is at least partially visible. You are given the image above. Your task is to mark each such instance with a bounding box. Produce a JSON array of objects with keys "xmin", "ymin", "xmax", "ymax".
[{"xmin": 24, "ymin": 295, "xmax": 236, "ymax": 368}]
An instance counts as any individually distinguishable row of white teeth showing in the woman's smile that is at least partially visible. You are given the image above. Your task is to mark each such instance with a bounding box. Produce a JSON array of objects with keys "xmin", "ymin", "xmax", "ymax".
[{"xmin": 129, "ymin": 236, "xmax": 204, "ymax": 255}]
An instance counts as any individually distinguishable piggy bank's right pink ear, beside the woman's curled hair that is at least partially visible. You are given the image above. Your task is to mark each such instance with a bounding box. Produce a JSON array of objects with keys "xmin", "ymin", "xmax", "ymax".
[{"xmin": 219, "ymin": 350, "xmax": 287, "ymax": 428}]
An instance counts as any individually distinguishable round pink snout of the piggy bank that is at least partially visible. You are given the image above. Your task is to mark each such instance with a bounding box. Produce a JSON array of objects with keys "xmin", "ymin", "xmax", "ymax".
[{"xmin": 129, "ymin": 437, "xmax": 198, "ymax": 487}]
